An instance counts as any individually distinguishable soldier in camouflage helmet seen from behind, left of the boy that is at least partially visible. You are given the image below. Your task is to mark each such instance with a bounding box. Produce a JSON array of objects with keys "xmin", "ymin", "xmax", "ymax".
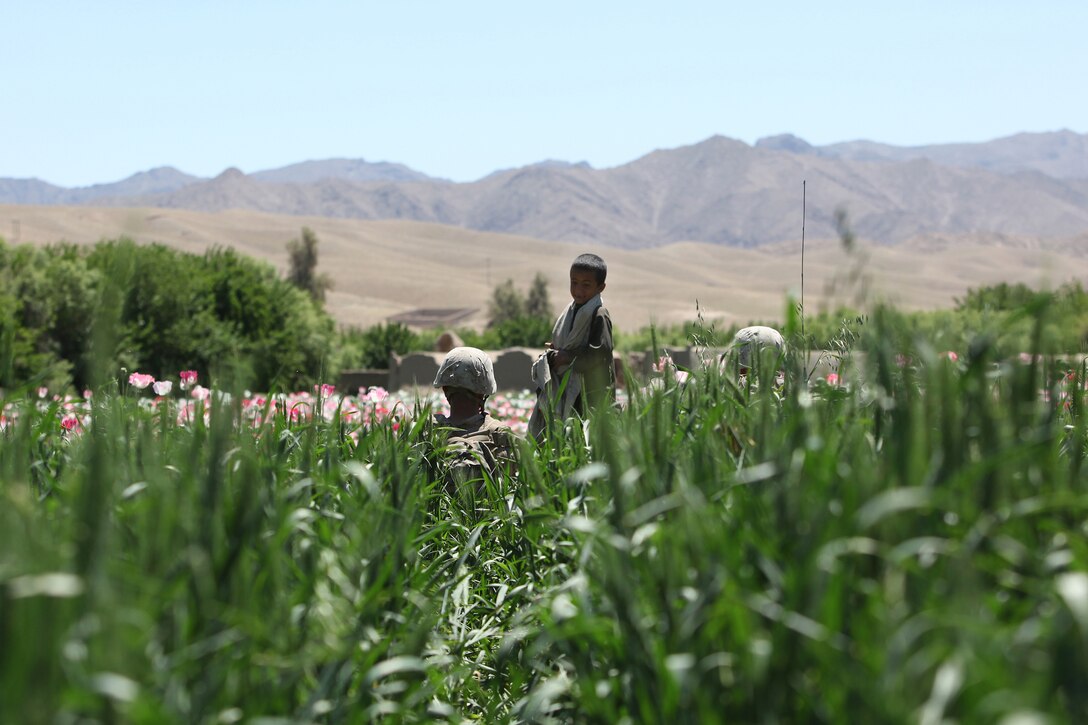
[{"xmin": 434, "ymin": 347, "xmax": 517, "ymax": 482}]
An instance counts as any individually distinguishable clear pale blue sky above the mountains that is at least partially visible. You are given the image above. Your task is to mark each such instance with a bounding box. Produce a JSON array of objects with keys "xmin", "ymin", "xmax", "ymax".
[{"xmin": 0, "ymin": 0, "xmax": 1088, "ymax": 186}]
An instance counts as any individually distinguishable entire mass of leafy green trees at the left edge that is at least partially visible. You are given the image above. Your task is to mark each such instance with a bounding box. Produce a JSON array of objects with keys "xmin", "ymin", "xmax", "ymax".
[{"xmin": 0, "ymin": 239, "xmax": 338, "ymax": 390}]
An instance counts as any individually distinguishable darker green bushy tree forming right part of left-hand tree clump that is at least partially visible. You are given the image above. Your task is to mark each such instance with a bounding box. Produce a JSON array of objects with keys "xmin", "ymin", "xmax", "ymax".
[{"xmin": 89, "ymin": 241, "xmax": 336, "ymax": 390}]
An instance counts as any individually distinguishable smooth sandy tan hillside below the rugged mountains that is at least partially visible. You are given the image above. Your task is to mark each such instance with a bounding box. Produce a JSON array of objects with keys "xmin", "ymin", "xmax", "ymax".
[{"xmin": 0, "ymin": 200, "xmax": 1088, "ymax": 329}]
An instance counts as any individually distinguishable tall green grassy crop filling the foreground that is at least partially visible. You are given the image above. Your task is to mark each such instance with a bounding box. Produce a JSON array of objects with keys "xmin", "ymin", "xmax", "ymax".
[{"xmin": 0, "ymin": 310, "xmax": 1088, "ymax": 724}]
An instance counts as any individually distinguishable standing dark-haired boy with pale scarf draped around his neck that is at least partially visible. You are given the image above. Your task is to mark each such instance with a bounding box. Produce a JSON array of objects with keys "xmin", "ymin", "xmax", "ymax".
[{"xmin": 529, "ymin": 254, "xmax": 616, "ymax": 440}]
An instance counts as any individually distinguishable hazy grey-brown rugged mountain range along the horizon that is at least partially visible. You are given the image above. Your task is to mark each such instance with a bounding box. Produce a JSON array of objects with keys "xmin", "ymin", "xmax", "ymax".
[{"xmin": 0, "ymin": 131, "xmax": 1088, "ymax": 249}]
